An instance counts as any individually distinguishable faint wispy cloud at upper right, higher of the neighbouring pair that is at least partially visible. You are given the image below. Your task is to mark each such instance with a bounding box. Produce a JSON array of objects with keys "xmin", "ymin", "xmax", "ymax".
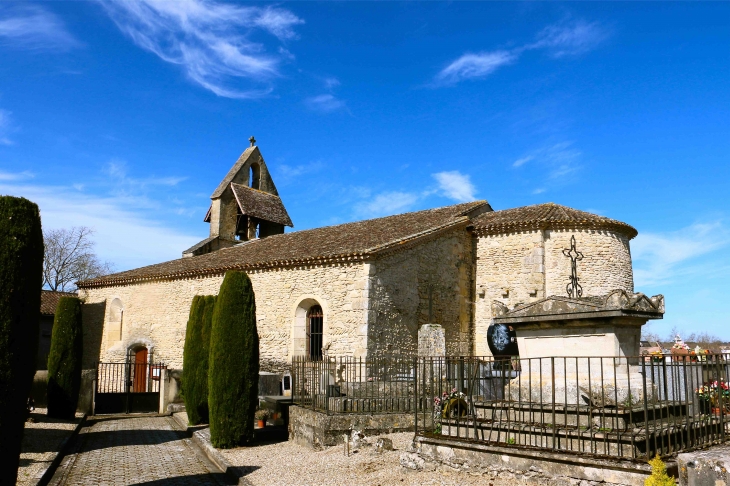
[{"xmin": 528, "ymin": 20, "xmax": 608, "ymax": 58}]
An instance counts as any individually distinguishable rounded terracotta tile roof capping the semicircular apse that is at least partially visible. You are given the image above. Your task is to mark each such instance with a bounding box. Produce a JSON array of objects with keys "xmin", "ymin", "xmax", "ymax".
[{"xmin": 473, "ymin": 203, "xmax": 638, "ymax": 239}]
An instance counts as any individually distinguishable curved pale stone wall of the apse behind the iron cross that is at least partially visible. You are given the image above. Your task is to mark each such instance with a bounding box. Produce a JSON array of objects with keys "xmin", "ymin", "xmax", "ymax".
[{"xmin": 473, "ymin": 229, "xmax": 634, "ymax": 356}]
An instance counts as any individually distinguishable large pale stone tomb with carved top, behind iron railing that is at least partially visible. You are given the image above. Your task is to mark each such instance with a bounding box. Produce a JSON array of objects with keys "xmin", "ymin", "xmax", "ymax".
[{"xmin": 493, "ymin": 290, "xmax": 664, "ymax": 407}]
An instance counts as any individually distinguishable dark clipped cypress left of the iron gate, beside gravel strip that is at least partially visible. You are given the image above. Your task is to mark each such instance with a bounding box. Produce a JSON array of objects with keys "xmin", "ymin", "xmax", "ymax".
[{"xmin": 48, "ymin": 297, "xmax": 84, "ymax": 418}]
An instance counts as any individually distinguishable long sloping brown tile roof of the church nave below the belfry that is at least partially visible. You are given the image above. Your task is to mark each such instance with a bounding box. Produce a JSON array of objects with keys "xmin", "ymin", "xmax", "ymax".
[{"xmin": 78, "ymin": 201, "xmax": 491, "ymax": 288}]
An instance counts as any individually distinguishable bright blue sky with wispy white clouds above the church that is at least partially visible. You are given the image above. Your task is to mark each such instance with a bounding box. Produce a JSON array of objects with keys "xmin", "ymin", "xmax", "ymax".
[{"xmin": 0, "ymin": 0, "xmax": 730, "ymax": 340}]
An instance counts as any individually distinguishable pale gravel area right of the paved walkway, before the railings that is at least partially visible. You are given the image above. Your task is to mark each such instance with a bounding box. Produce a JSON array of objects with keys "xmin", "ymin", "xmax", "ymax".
[{"xmin": 220, "ymin": 432, "xmax": 517, "ymax": 486}]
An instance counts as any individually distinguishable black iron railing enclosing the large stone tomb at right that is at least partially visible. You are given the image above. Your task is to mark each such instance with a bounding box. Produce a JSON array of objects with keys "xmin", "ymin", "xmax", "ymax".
[{"xmin": 414, "ymin": 355, "xmax": 730, "ymax": 459}]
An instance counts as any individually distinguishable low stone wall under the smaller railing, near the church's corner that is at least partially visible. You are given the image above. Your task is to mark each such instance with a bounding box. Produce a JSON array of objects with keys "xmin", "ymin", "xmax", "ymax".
[{"xmin": 289, "ymin": 405, "xmax": 414, "ymax": 449}]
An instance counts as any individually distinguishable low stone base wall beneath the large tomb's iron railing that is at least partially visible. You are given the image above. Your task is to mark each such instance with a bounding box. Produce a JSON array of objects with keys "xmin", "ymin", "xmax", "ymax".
[{"xmin": 401, "ymin": 437, "xmax": 651, "ymax": 486}]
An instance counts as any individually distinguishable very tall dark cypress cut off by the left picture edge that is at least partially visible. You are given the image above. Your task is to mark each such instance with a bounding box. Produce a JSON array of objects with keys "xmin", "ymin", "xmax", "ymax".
[{"xmin": 0, "ymin": 196, "xmax": 43, "ymax": 484}]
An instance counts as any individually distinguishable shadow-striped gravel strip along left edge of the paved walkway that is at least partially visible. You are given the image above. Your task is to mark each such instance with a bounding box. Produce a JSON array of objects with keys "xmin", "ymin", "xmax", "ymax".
[{"xmin": 17, "ymin": 408, "xmax": 83, "ymax": 486}]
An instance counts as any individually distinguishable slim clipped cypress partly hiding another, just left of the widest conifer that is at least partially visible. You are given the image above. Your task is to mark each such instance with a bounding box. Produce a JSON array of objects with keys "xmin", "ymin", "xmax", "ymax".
[{"xmin": 182, "ymin": 295, "xmax": 203, "ymax": 425}]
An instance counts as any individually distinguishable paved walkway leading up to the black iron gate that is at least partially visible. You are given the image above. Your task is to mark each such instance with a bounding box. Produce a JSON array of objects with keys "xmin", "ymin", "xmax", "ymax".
[{"xmin": 54, "ymin": 417, "xmax": 227, "ymax": 486}]
